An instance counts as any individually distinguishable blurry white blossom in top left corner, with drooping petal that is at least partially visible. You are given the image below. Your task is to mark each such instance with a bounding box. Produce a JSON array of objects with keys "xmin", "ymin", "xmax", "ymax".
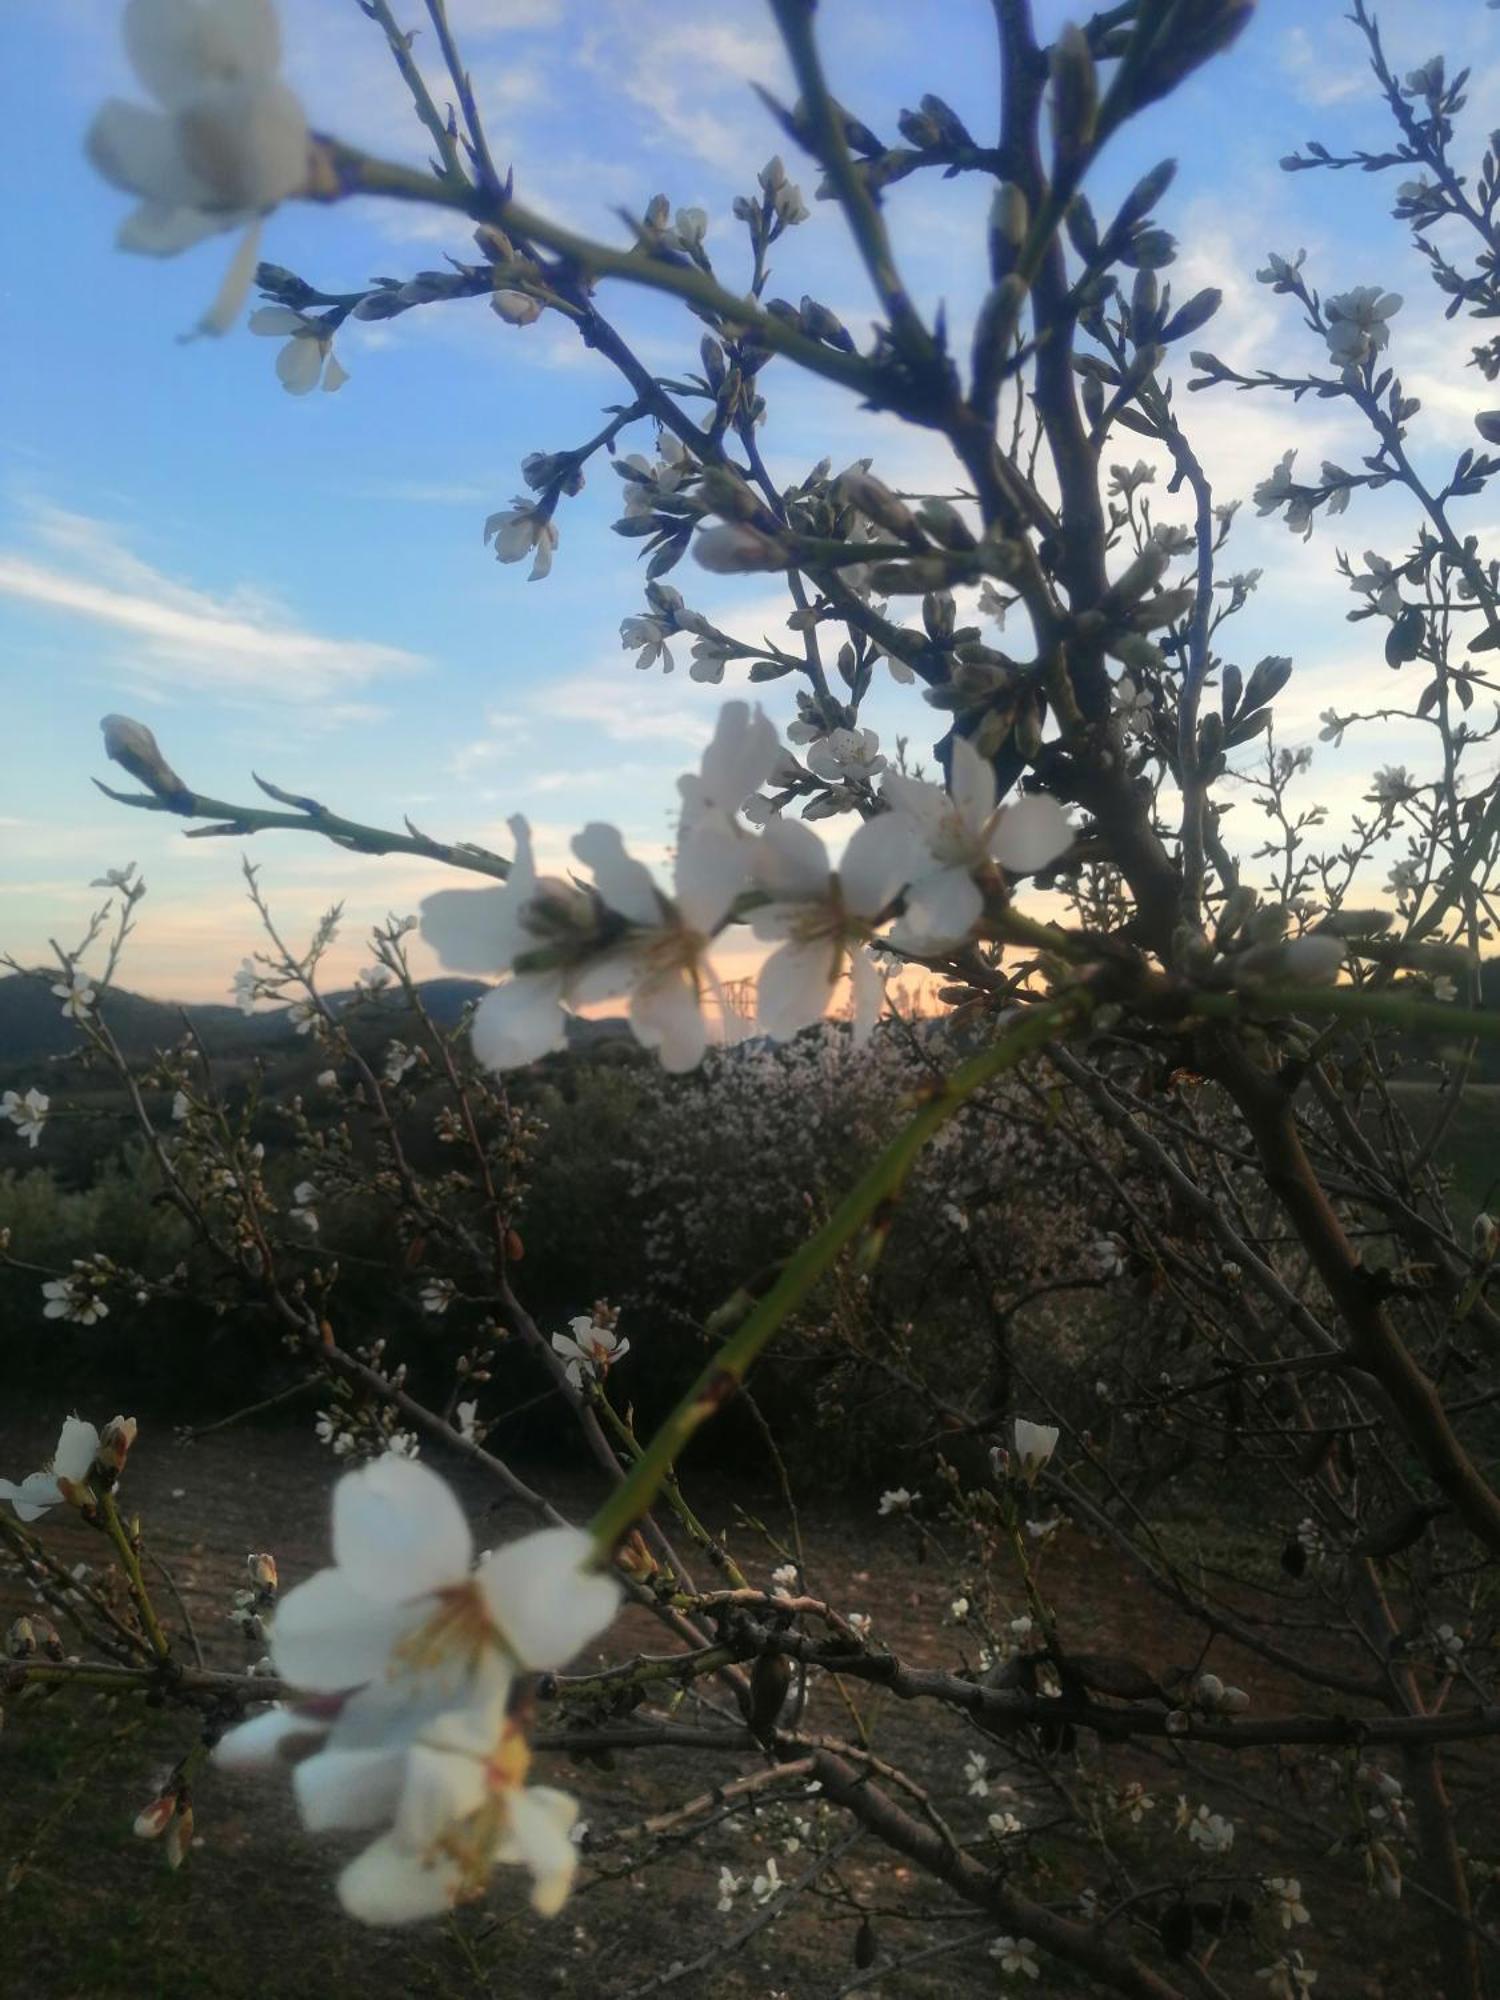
[{"xmin": 86, "ymin": 0, "xmax": 308, "ymax": 334}]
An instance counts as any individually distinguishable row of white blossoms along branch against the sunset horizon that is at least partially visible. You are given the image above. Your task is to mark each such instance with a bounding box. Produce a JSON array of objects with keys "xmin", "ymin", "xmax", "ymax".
[{"xmin": 422, "ymin": 702, "xmax": 1072, "ymax": 1070}]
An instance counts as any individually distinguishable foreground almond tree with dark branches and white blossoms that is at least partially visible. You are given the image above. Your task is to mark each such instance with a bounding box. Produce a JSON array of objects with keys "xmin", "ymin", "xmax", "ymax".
[{"xmin": 0, "ymin": 0, "xmax": 1500, "ymax": 2000}]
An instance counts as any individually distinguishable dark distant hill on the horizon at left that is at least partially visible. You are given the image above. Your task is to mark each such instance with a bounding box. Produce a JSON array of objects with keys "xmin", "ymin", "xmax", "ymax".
[{"xmin": 0, "ymin": 974, "xmax": 628, "ymax": 1072}]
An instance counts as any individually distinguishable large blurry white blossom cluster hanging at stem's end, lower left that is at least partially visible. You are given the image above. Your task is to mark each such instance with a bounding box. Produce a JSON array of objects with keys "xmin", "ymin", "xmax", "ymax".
[{"xmin": 216, "ymin": 1454, "xmax": 620, "ymax": 1924}]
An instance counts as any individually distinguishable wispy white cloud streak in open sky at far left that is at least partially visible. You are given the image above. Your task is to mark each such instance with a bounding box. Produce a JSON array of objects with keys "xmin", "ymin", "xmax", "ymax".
[{"xmin": 0, "ymin": 506, "xmax": 426, "ymax": 718}]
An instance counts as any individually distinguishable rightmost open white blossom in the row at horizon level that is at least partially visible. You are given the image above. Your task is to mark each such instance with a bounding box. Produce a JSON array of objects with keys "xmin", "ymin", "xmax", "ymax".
[{"xmin": 880, "ymin": 736, "xmax": 1072, "ymax": 950}]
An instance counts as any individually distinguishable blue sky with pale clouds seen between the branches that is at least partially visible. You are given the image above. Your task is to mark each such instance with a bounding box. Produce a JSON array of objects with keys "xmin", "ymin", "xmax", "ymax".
[{"xmin": 0, "ymin": 0, "xmax": 1500, "ymax": 998}]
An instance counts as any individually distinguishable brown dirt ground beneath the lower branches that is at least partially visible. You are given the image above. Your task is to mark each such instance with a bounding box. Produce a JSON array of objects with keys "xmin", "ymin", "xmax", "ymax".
[{"xmin": 0, "ymin": 1412, "xmax": 1480, "ymax": 2000}]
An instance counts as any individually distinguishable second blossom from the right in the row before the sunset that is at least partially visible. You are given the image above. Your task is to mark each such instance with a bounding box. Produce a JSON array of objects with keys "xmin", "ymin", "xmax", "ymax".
[{"xmin": 750, "ymin": 812, "xmax": 912, "ymax": 1044}]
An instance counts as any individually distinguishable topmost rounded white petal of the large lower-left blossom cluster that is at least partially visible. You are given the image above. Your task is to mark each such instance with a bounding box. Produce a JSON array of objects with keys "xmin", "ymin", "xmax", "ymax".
[{"xmin": 334, "ymin": 1452, "xmax": 474, "ymax": 1622}]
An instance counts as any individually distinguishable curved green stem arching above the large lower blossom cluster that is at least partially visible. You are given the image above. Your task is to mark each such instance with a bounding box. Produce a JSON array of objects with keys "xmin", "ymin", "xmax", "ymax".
[{"xmin": 588, "ymin": 988, "xmax": 1094, "ymax": 1562}]
